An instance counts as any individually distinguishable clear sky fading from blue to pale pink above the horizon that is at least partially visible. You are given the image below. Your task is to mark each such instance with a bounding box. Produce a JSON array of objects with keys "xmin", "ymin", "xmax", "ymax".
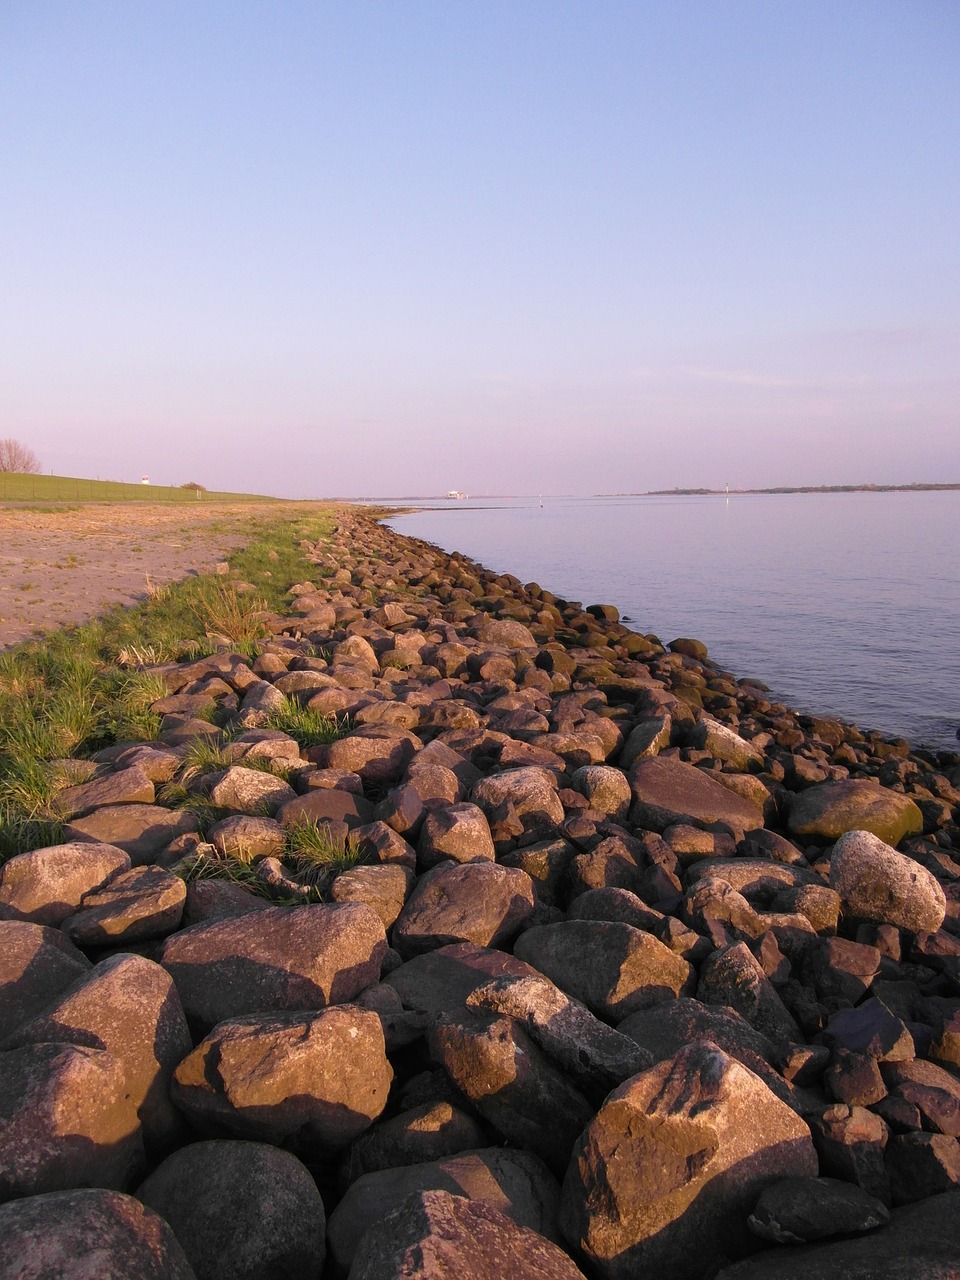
[{"xmin": 0, "ymin": 0, "xmax": 960, "ymax": 497}]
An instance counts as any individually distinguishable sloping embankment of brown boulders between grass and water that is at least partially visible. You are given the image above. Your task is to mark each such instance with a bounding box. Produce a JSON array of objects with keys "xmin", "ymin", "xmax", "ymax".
[{"xmin": 0, "ymin": 515, "xmax": 960, "ymax": 1280}]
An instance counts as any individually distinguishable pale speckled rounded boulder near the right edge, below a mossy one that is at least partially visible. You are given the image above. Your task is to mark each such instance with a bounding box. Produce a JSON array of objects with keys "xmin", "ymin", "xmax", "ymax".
[{"xmin": 829, "ymin": 829, "xmax": 946, "ymax": 933}]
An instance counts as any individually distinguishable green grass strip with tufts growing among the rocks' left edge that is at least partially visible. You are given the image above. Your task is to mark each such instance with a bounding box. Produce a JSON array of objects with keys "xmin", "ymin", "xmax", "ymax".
[{"xmin": 0, "ymin": 504, "xmax": 358, "ymax": 881}]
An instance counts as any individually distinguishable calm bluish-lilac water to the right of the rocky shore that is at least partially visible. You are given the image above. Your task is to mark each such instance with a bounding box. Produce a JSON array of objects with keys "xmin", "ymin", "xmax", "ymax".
[{"xmin": 390, "ymin": 492, "xmax": 960, "ymax": 748}]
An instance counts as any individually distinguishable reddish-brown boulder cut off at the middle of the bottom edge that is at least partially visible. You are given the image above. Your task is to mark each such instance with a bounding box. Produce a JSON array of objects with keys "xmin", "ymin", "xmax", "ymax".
[{"xmin": 349, "ymin": 1192, "xmax": 584, "ymax": 1280}]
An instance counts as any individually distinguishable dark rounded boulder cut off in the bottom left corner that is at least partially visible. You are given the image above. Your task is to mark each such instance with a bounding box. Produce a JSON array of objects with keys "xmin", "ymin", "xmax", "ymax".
[{"xmin": 0, "ymin": 1189, "xmax": 200, "ymax": 1280}]
